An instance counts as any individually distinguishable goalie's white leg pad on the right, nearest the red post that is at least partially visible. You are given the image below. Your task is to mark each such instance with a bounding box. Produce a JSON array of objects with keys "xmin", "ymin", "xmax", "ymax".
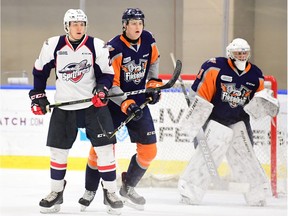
[{"xmin": 226, "ymin": 121, "xmax": 268, "ymax": 205}]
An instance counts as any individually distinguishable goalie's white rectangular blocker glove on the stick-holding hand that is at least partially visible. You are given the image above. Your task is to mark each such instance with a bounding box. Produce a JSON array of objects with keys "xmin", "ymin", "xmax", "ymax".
[{"xmin": 180, "ymin": 95, "xmax": 214, "ymax": 139}]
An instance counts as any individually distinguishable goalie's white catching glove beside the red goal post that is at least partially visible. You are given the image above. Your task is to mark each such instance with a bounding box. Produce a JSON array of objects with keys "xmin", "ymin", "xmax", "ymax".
[{"xmin": 244, "ymin": 89, "xmax": 280, "ymax": 119}]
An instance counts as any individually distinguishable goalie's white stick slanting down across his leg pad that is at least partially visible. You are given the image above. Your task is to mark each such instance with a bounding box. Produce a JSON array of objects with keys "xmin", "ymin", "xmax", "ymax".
[{"xmin": 170, "ymin": 53, "xmax": 248, "ymax": 192}]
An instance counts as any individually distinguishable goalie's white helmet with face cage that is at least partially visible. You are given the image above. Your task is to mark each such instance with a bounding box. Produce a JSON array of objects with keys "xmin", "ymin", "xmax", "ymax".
[{"xmin": 226, "ymin": 38, "xmax": 250, "ymax": 71}]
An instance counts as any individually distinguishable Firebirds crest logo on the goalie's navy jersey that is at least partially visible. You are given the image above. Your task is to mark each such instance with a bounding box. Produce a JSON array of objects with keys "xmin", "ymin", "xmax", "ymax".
[{"xmin": 221, "ymin": 83, "xmax": 252, "ymax": 108}]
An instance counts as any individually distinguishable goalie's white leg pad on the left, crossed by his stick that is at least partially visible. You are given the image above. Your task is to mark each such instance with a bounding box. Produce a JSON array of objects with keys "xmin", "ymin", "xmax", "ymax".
[{"xmin": 178, "ymin": 120, "xmax": 233, "ymax": 204}]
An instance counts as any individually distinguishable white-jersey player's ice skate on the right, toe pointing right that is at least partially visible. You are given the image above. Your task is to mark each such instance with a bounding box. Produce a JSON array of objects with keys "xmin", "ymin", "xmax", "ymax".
[{"xmin": 102, "ymin": 184, "xmax": 123, "ymax": 215}]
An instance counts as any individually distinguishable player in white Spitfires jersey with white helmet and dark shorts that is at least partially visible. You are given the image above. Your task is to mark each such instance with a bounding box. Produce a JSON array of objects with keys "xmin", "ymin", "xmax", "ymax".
[{"xmin": 29, "ymin": 9, "xmax": 123, "ymax": 213}]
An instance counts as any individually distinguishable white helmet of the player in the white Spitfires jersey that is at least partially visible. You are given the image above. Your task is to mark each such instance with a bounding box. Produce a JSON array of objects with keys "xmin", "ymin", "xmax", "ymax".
[{"xmin": 63, "ymin": 9, "xmax": 88, "ymax": 34}]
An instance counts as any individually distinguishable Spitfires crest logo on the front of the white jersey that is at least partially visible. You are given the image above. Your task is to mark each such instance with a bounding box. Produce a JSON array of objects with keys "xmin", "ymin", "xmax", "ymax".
[{"xmin": 59, "ymin": 59, "xmax": 91, "ymax": 83}]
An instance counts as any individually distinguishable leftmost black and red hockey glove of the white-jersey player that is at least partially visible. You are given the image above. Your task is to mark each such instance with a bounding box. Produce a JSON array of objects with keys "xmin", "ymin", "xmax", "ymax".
[{"xmin": 29, "ymin": 89, "xmax": 50, "ymax": 115}]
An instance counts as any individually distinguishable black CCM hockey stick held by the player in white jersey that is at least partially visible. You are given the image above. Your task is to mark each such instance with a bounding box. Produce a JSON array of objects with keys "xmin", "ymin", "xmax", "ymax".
[{"xmin": 46, "ymin": 60, "xmax": 182, "ymax": 110}]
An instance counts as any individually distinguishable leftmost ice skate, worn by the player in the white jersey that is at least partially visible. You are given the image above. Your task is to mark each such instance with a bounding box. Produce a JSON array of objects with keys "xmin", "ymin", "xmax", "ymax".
[{"xmin": 39, "ymin": 180, "xmax": 66, "ymax": 214}]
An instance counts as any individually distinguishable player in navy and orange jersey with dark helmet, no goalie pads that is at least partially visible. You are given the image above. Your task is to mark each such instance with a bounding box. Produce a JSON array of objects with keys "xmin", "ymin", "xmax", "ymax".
[{"xmin": 79, "ymin": 8, "xmax": 162, "ymax": 209}]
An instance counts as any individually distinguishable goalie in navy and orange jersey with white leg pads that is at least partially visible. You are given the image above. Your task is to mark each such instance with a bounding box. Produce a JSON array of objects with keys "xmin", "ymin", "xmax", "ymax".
[{"xmin": 178, "ymin": 38, "xmax": 279, "ymax": 206}]
